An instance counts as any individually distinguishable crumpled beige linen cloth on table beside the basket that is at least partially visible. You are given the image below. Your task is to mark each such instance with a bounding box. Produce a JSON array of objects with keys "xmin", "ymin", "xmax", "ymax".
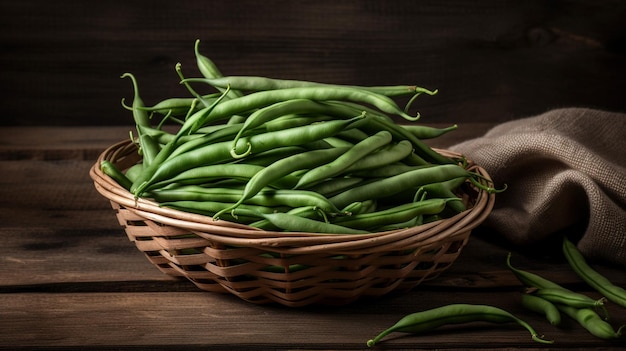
[{"xmin": 450, "ymin": 108, "xmax": 626, "ymax": 266}]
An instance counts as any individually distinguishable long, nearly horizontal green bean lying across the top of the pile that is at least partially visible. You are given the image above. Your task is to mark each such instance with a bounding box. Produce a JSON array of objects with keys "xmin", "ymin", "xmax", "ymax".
[{"xmin": 178, "ymin": 76, "xmax": 437, "ymax": 97}]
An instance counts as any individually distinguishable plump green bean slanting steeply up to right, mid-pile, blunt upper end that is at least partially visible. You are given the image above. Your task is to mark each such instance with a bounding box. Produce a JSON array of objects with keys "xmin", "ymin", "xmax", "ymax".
[{"xmin": 295, "ymin": 131, "xmax": 391, "ymax": 189}]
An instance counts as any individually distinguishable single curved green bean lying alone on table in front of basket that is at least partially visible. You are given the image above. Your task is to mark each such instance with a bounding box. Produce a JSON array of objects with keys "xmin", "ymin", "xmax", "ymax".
[{"xmin": 367, "ymin": 304, "xmax": 552, "ymax": 347}]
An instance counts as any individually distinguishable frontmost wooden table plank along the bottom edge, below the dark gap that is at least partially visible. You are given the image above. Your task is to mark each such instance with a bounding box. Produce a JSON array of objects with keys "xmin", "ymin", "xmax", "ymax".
[{"xmin": 0, "ymin": 291, "xmax": 625, "ymax": 350}]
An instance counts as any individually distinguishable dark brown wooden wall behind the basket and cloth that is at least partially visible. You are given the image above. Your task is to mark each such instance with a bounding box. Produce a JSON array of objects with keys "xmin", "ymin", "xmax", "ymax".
[{"xmin": 0, "ymin": 0, "xmax": 626, "ymax": 126}]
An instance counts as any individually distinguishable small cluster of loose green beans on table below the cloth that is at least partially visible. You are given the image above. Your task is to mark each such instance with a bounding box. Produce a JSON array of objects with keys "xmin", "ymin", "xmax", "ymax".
[{"xmin": 506, "ymin": 253, "xmax": 626, "ymax": 340}]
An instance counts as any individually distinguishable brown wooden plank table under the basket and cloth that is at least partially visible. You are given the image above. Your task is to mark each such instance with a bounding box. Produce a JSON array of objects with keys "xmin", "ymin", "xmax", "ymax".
[{"xmin": 0, "ymin": 124, "xmax": 626, "ymax": 350}]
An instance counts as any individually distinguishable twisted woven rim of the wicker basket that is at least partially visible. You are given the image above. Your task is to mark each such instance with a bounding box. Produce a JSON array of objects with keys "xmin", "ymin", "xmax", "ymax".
[{"xmin": 89, "ymin": 140, "xmax": 495, "ymax": 254}]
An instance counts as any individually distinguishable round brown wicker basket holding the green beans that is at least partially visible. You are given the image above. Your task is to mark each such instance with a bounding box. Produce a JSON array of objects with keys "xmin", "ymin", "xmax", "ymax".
[{"xmin": 90, "ymin": 141, "xmax": 494, "ymax": 306}]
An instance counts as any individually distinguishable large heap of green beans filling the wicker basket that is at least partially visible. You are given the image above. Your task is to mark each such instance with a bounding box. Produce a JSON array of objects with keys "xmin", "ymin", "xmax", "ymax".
[{"xmin": 101, "ymin": 41, "xmax": 499, "ymax": 234}]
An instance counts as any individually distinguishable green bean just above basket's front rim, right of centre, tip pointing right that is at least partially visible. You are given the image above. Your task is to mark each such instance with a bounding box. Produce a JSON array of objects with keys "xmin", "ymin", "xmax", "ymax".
[{"xmin": 334, "ymin": 198, "xmax": 459, "ymax": 230}]
